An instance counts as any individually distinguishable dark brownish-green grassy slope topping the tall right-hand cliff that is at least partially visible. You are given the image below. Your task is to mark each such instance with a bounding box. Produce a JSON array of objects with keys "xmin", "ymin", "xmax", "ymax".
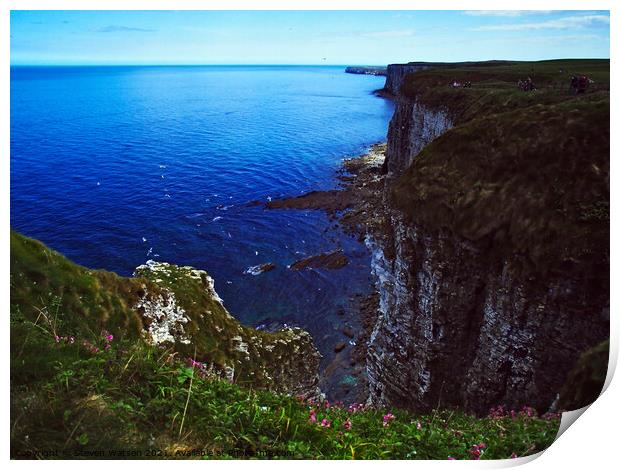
[{"xmin": 394, "ymin": 60, "xmax": 609, "ymax": 280}]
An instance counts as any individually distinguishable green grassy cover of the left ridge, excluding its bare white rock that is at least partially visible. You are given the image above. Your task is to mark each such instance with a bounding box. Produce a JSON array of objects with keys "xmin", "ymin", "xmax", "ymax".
[{"xmin": 11, "ymin": 232, "xmax": 318, "ymax": 390}]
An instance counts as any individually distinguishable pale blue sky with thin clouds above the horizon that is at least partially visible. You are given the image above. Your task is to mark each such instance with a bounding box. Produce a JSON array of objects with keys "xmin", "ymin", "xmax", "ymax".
[{"xmin": 11, "ymin": 11, "xmax": 609, "ymax": 65}]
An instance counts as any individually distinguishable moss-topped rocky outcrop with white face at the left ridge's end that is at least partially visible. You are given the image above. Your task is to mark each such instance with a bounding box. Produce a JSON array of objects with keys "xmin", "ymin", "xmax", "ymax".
[{"xmin": 133, "ymin": 261, "xmax": 321, "ymax": 397}]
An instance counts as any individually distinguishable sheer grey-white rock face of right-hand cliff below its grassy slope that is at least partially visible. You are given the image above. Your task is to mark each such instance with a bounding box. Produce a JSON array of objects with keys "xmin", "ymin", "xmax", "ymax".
[{"xmin": 367, "ymin": 65, "xmax": 609, "ymax": 413}]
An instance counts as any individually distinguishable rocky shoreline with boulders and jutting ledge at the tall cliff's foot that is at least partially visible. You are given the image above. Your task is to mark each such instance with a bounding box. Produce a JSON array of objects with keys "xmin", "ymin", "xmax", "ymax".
[{"xmin": 265, "ymin": 143, "xmax": 387, "ymax": 402}]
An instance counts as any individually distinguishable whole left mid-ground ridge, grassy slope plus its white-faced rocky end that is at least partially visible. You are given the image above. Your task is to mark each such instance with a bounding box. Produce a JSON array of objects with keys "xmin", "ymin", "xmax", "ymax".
[{"xmin": 11, "ymin": 231, "xmax": 322, "ymax": 397}]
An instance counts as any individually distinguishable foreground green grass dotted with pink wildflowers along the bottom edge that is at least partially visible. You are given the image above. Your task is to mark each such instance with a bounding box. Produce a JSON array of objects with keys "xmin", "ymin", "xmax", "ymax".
[{"xmin": 11, "ymin": 315, "xmax": 559, "ymax": 459}]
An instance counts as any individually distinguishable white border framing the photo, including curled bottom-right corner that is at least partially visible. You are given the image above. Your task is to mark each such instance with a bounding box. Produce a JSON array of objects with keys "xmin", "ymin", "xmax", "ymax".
[{"xmin": 0, "ymin": 0, "xmax": 620, "ymax": 469}]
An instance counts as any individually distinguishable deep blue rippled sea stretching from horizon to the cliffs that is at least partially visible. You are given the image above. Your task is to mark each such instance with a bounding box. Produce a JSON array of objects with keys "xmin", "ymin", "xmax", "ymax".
[{"xmin": 10, "ymin": 66, "xmax": 393, "ymax": 364}]
